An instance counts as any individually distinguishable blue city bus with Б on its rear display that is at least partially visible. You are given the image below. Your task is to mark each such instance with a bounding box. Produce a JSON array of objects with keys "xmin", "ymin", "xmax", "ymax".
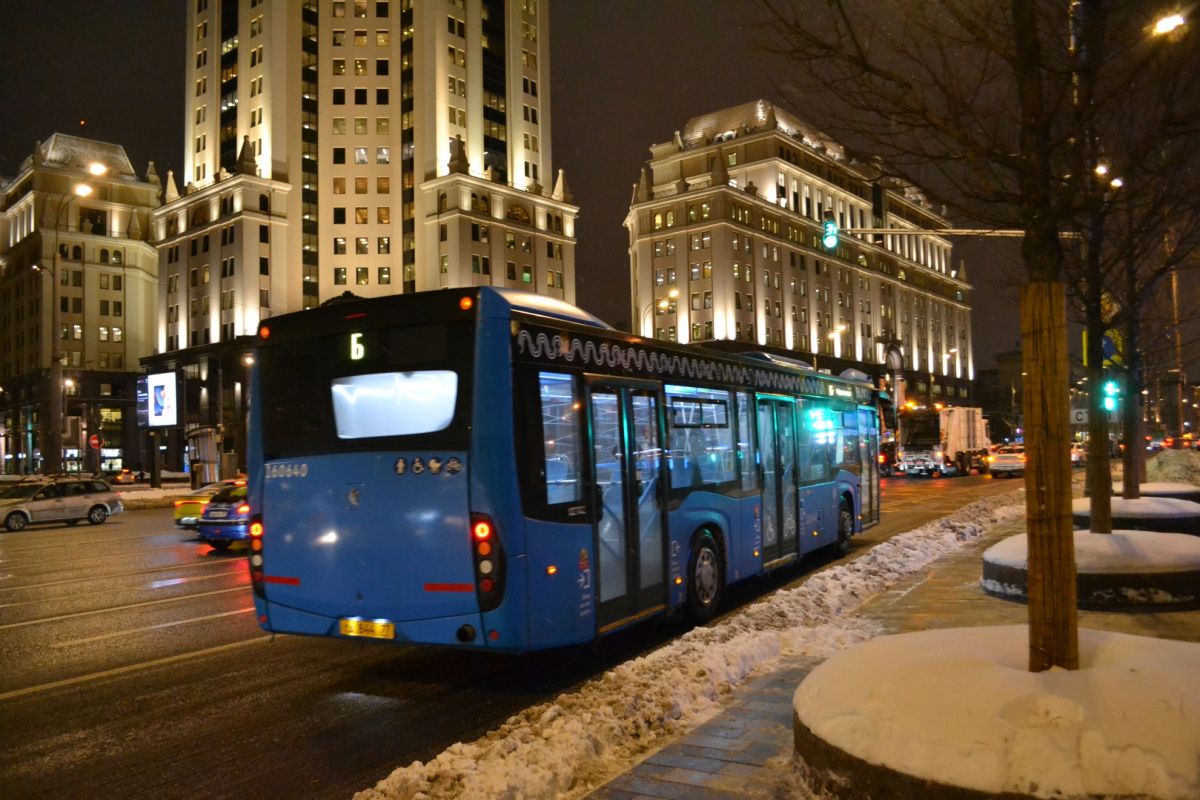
[{"xmin": 248, "ymin": 287, "xmax": 886, "ymax": 651}]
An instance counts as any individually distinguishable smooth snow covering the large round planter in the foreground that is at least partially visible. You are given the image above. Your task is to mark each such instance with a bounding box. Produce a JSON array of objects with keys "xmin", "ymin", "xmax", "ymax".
[{"xmin": 793, "ymin": 626, "xmax": 1200, "ymax": 800}]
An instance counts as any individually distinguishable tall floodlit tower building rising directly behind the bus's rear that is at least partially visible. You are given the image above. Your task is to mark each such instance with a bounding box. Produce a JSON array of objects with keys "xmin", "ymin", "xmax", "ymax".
[{"xmin": 155, "ymin": 0, "xmax": 577, "ymax": 353}]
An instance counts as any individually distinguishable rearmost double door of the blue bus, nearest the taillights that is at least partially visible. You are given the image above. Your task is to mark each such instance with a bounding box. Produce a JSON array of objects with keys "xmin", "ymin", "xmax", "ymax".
[{"xmin": 588, "ymin": 379, "xmax": 666, "ymax": 633}]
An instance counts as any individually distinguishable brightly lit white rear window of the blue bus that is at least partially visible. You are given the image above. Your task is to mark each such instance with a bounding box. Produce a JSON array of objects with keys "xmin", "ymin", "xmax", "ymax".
[{"xmin": 331, "ymin": 369, "xmax": 458, "ymax": 439}]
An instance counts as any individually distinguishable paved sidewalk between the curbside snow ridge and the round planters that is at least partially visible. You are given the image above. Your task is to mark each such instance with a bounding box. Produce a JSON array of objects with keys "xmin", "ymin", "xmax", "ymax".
[{"xmin": 588, "ymin": 519, "xmax": 1200, "ymax": 800}]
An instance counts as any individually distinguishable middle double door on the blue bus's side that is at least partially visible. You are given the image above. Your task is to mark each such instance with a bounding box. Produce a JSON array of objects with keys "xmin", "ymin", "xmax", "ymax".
[{"xmin": 758, "ymin": 398, "xmax": 800, "ymax": 564}]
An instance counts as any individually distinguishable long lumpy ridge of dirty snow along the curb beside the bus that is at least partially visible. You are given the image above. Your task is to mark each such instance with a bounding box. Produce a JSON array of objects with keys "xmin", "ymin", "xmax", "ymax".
[{"xmin": 354, "ymin": 492, "xmax": 1025, "ymax": 800}]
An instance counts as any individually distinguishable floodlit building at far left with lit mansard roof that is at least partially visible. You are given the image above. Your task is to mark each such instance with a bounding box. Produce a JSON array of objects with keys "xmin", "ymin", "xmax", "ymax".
[{"xmin": 0, "ymin": 133, "xmax": 162, "ymax": 473}]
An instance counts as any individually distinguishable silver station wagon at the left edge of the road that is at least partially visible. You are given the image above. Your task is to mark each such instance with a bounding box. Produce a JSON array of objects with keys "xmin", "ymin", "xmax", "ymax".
[{"xmin": 0, "ymin": 479, "xmax": 125, "ymax": 531}]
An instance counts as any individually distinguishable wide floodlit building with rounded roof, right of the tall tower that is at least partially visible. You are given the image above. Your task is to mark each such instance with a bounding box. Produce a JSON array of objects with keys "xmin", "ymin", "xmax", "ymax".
[{"xmin": 625, "ymin": 101, "xmax": 974, "ymax": 402}]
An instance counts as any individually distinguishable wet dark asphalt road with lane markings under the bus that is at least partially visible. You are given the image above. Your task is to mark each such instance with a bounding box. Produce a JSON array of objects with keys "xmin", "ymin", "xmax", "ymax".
[{"xmin": 0, "ymin": 476, "xmax": 1021, "ymax": 800}]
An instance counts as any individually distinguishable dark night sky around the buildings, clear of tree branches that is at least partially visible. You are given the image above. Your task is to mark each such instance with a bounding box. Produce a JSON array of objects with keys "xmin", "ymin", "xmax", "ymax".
[{"xmin": 0, "ymin": 0, "xmax": 1020, "ymax": 368}]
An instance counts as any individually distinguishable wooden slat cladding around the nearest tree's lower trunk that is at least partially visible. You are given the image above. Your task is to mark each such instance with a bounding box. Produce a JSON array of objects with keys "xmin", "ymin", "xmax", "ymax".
[{"xmin": 1021, "ymin": 281, "xmax": 1079, "ymax": 672}]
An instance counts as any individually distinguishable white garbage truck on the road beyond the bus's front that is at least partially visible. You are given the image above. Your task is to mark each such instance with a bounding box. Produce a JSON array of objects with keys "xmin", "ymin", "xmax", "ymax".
[{"xmin": 896, "ymin": 405, "xmax": 991, "ymax": 477}]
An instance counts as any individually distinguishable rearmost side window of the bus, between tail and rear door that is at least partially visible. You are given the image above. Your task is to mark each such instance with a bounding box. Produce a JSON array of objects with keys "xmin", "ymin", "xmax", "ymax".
[{"xmin": 538, "ymin": 372, "xmax": 583, "ymax": 505}]
